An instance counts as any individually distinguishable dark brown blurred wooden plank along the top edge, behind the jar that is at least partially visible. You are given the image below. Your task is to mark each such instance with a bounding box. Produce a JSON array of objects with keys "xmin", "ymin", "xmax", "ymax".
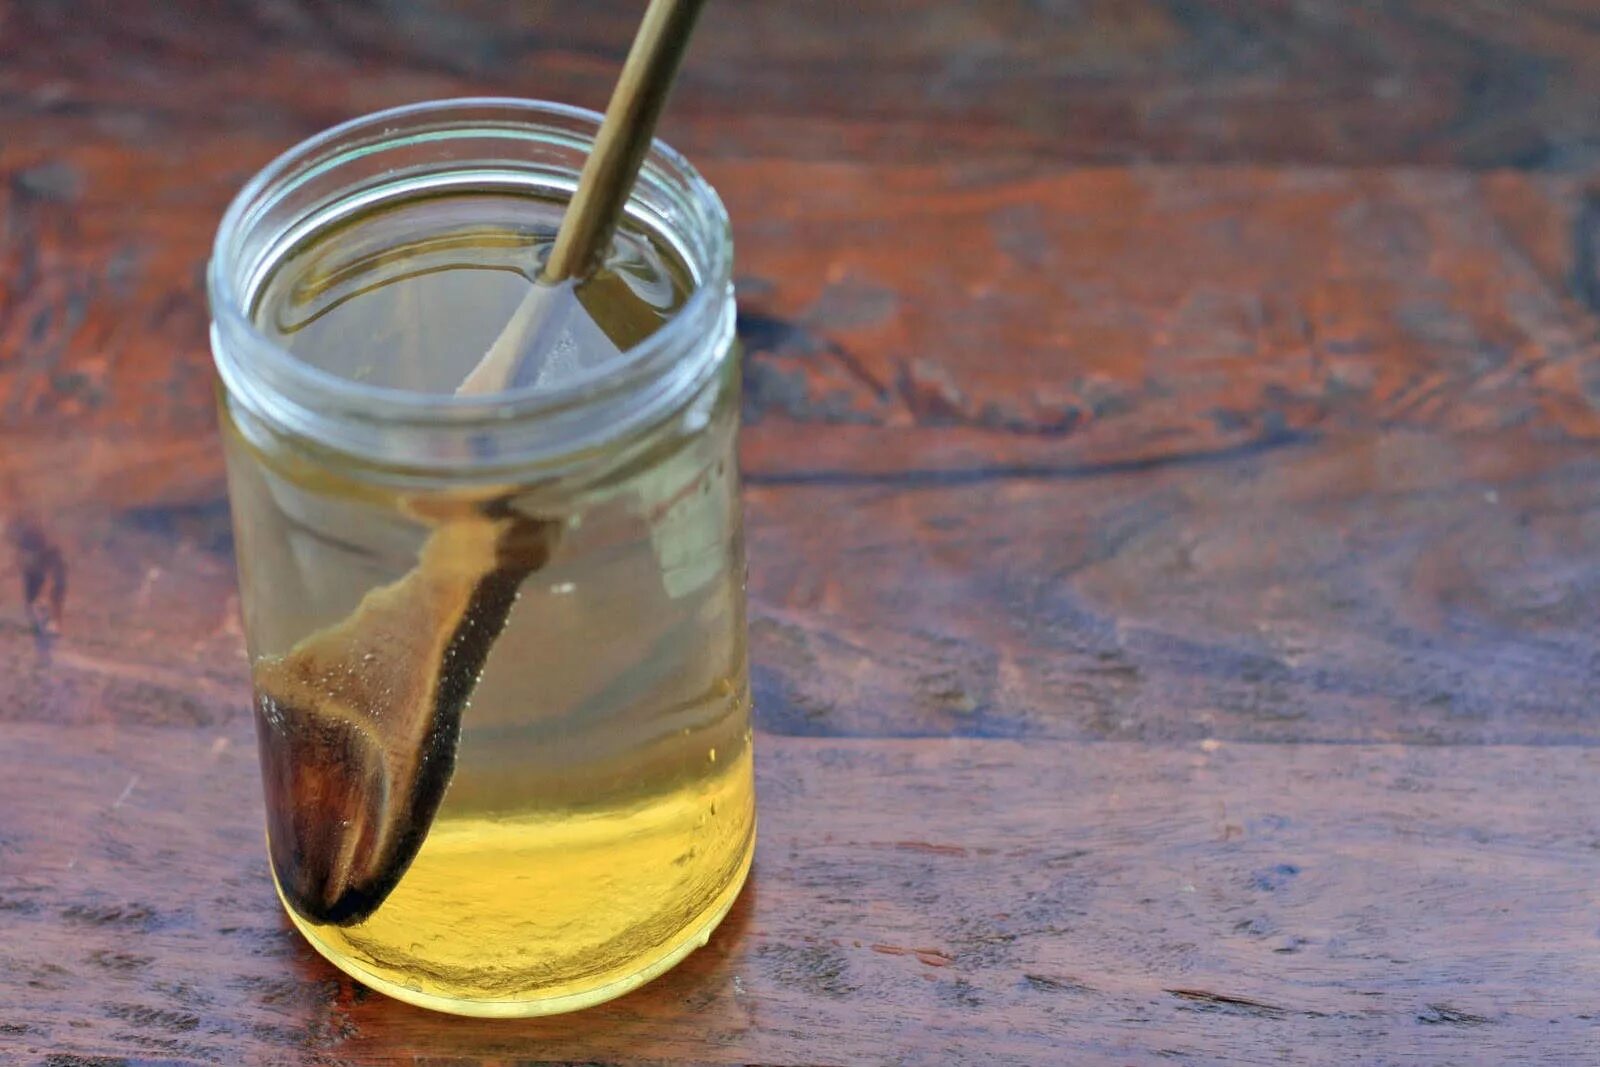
[{"xmin": 0, "ymin": 0, "xmax": 1600, "ymax": 170}]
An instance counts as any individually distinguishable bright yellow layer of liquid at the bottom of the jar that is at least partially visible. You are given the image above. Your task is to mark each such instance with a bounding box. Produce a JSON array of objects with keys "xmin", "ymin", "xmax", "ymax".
[{"xmin": 290, "ymin": 747, "xmax": 755, "ymax": 1017}]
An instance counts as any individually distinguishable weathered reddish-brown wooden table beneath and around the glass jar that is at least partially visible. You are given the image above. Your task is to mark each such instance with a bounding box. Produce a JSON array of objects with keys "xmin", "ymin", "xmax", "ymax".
[{"xmin": 0, "ymin": 0, "xmax": 1600, "ymax": 1067}]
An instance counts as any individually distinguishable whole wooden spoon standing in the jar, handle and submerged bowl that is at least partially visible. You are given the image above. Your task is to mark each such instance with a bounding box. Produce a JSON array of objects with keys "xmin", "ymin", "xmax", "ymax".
[{"xmin": 254, "ymin": 0, "xmax": 702, "ymax": 925}]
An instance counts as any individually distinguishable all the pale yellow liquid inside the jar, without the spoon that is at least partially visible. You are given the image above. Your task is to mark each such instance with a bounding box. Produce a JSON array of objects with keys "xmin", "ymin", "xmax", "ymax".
[{"xmin": 233, "ymin": 195, "xmax": 755, "ymax": 1016}]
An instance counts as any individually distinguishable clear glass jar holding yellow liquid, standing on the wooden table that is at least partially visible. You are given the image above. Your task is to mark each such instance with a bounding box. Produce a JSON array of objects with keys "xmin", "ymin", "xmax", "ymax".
[{"xmin": 208, "ymin": 99, "xmax": 755, "ymax": 1016}]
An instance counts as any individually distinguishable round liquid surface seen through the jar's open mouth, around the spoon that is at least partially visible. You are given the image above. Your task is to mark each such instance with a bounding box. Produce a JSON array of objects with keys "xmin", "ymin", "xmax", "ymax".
[{"xmin": 254, "ymin": 192, "xmax": 688, "ymax": 394}]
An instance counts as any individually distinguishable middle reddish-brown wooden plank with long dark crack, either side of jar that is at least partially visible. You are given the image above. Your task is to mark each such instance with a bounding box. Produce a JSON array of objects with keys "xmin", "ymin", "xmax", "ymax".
[{"xmin": 0, "ymin": 160, "xmax": 1600, "ymax": 744}]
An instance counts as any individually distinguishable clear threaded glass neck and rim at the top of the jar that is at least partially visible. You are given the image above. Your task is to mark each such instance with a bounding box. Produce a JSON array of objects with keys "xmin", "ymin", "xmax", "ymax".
[{"xmin": 206, "ymin": 99, "xmax": 734, "ymax": 475}]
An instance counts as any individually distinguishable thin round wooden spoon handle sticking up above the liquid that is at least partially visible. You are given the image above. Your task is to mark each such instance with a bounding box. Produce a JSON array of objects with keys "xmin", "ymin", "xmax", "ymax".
[{"xmin": 541, "ymin": 0, "xmax": 706, "ymax": 282}]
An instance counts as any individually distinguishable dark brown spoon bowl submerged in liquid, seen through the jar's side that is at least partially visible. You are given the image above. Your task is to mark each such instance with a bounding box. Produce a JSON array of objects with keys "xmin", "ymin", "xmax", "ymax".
[{"xmin": 254, "ymin": 504, "xmax": 560, "ymax": 926}]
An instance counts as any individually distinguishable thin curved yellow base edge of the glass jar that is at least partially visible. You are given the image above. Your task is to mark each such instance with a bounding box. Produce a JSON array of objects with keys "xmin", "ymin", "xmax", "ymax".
[{"xmin": 269, "ymin": 824, "xmax": 755, "ymax": 1019}]
